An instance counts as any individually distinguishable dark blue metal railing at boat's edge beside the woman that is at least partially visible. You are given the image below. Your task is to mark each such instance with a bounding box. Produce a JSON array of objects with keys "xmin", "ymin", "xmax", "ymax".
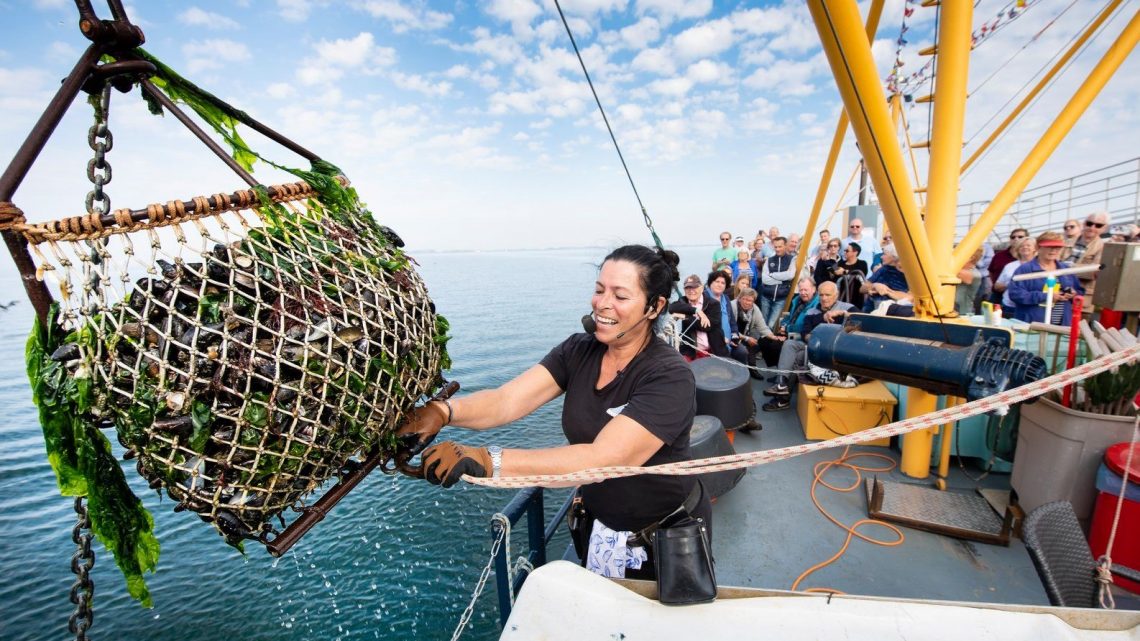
[{"xmin": 491, "ymin": 487, "xmax": 573, "ymax": 626}]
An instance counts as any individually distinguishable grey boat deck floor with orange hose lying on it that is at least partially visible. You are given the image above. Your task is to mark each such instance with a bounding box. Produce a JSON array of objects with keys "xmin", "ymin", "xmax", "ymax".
[{"xmin": 713, "ymin": 381, "xmax": 1140, "ymax": 609}]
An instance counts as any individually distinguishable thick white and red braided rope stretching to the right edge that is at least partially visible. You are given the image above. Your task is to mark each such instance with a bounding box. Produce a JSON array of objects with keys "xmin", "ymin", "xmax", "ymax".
[{"xmin": 463, "ymin": 343, "xmax": 1140, "ymax": 488}]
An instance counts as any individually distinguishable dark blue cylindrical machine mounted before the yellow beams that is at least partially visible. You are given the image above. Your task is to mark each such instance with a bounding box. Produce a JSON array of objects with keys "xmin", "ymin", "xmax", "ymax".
[{"xmin": 807, "ymin": 314, "xmax": 1047, "ymax": 400}]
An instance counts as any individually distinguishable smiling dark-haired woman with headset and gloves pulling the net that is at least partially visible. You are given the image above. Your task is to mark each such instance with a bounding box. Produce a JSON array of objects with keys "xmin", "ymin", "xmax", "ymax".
[{"xmin": 398, "ymin": 245, "xmax": 711, "ymax": 578}]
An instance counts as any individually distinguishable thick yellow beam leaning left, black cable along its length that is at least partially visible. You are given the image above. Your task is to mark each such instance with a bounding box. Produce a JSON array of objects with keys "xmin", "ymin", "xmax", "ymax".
[{"xmin": 807, "ymin": 0, "xmax": 951, "ymax": 317}]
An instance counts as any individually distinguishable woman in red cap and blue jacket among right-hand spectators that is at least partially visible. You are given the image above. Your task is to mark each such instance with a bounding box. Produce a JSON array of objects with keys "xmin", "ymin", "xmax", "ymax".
[{"xmin": 1009, "ymin": 232, "xmax": 1084, "ymax": 325}]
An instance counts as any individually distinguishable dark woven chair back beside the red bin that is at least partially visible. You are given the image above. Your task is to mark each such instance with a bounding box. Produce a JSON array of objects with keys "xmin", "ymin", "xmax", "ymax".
[{"xmin": 1021, "ymin": 501, "xmax": 1140, "ymax": 608}]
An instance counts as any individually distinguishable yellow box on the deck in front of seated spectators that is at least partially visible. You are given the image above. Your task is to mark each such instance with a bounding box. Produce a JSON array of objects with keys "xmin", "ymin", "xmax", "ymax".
[{"xmin": 796, "ymin": 381, "xmax": 898, "ymax": 446}]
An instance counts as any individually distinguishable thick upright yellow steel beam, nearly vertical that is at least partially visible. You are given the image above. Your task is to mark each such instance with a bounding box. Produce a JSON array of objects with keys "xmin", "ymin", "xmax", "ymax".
[{"xmin": 926, "ymin": 2, "xmax": 974, "ymax": 274}]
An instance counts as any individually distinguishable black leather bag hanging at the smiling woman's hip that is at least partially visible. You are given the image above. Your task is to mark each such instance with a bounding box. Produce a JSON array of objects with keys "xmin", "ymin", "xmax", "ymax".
[{"xmin": 653, "ymin": 514, "xmax": 717, "ymax": 606}]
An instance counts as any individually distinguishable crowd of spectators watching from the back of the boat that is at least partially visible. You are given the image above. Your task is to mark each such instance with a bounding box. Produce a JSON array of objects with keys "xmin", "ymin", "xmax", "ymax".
[{"xmin": 669, "ymin": 212, "xmax": 1140, "ymax": 411}]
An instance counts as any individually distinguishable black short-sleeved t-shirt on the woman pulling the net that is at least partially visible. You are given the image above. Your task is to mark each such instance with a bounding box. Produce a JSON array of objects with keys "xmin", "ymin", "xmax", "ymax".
[{"xmin": 540, "ymin": 334, "xmax": 697, "ymax": 530}]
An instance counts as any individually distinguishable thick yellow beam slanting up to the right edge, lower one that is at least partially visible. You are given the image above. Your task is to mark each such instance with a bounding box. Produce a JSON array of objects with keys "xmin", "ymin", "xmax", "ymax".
[{"xmin": 951, "ymin": 11, "xmax": 1140, "ymax": 268}]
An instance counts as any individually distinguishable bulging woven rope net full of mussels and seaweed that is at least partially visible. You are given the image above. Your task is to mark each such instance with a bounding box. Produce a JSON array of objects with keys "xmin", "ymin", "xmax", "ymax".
[{"xmin": 16, "ymin": 179, "xmax": 447, "ymax": 543}]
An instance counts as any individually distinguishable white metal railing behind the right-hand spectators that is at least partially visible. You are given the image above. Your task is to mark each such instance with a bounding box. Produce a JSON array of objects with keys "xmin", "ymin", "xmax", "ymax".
[{"xmin": 954, "ymin": 157, "xmax": 1140, "ymax": 242}]
